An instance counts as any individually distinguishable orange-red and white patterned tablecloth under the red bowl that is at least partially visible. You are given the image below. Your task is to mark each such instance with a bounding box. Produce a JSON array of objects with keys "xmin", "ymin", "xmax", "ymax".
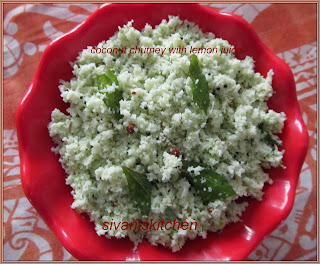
[{"xmin": 3, "ymin": 3, "xmax": 317, "ymax": 260}]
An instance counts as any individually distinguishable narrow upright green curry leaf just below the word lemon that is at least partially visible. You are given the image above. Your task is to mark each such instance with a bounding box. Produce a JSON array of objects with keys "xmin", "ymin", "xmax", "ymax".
[{"xmin": 189, "ymin": 54, "xmax": 209, "ymax": 113}]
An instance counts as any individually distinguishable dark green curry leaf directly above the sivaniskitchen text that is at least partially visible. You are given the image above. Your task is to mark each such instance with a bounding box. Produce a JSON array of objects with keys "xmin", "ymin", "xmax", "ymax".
[{"xmin": 122, "ymin": 167, "xmax": 152, "ymax": 216}]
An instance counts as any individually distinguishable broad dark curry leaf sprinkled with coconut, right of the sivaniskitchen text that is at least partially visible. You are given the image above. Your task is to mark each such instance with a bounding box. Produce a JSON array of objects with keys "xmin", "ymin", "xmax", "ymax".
[{"xmin": 182, "ymin": 160, "xmax": 236, "ymax": 203}]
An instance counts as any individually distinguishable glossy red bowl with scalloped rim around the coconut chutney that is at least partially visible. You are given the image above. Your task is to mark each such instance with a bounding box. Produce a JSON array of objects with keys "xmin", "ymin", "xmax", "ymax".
[{"xmin": 16, "ymin": 4, "xmax": 308, "ymax": 260}]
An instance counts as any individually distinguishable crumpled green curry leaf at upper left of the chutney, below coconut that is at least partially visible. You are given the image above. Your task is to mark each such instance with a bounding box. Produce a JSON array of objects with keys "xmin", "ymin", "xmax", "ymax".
[{"xmin": 97, "ymin": 70, "xmax": 122, "ymax": 120}]
